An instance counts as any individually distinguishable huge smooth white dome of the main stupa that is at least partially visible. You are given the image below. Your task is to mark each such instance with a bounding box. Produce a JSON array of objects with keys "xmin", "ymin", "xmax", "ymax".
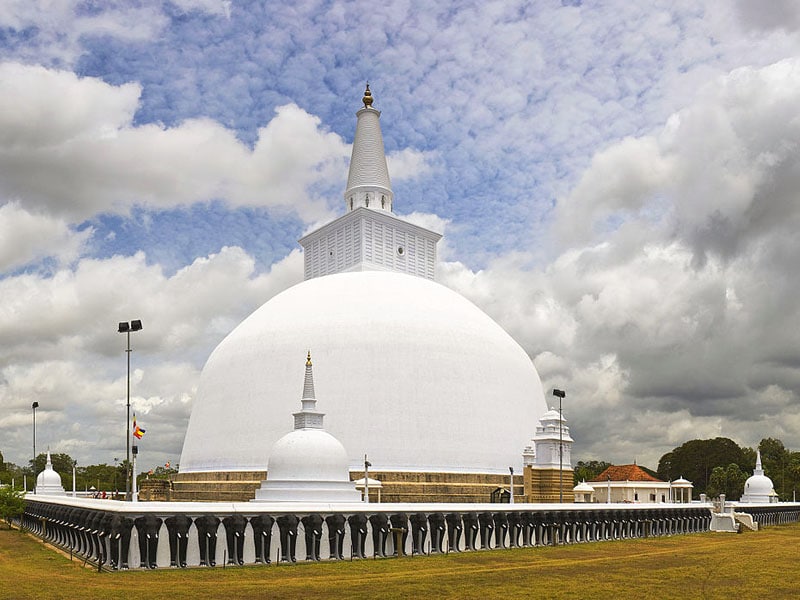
[{"xmin": 180, "ymin": 271, "xmax": 547, "ymax": 473}]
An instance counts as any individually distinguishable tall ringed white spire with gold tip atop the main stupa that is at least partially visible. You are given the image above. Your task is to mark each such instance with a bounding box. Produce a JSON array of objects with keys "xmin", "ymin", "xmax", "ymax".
[{"xmin": 344, "ymin": 83, "xmax": 394, "ymax": 212}]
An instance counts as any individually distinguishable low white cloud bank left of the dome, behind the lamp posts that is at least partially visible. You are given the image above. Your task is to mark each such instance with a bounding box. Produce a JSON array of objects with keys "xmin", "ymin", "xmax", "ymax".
[{"xmin": 0, "ymin": 248, "xmax": 303, "ymax": 463}]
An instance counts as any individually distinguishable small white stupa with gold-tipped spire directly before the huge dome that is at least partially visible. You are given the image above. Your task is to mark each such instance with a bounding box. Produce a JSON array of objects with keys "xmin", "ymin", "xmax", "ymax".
[{"xmin": 253, "ymin": 352, "xmax": 361, "ymax": 502}]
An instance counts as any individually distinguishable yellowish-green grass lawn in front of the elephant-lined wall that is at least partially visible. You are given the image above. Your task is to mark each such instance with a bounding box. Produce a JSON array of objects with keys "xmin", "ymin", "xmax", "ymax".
[{"xmin": 0, "ymin": 524, "xmax": 800, "ymax": 600}]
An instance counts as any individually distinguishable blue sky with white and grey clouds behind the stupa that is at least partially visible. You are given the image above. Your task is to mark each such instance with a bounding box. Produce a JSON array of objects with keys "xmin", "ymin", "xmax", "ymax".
[{"xmin": 0, "ymin": 0, "xmax": 800, "ymax": 476}]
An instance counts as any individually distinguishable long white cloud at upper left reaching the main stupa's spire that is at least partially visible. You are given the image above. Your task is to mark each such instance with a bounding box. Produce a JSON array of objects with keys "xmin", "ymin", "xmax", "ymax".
[{"xmin": 0, "ymin": 63, "xmax": 438, "ymax": 227}]
